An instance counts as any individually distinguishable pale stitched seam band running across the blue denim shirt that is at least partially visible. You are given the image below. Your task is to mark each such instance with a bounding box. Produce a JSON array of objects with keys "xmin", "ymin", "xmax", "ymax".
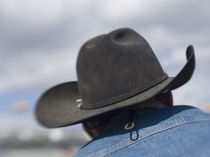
[{"xmin": 88, "ymin": 117, "xmax": 210, "ymax": 157}]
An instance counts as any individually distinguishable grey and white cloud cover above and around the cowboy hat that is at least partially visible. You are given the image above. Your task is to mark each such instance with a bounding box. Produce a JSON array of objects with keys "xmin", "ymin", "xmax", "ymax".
[{"xmin": 0, "ymin": 0, "xmax": 210, "ymax": 109}]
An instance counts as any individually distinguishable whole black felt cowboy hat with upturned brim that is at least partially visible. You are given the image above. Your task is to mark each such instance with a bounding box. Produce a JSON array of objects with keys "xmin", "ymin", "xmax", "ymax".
[{"xmin": 36, "ymin": 28, "xmax": 195, "ymax": 128}]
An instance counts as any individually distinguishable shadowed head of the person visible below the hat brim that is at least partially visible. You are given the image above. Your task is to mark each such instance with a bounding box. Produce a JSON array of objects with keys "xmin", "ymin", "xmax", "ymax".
[{"xmin": 82, "ymin": 91, "xmax": 173, "ymax": 138}]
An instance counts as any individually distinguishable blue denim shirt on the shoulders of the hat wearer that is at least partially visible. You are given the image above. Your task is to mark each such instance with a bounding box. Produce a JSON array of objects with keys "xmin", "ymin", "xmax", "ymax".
[{"xmin": 75, "ymin": 106, "xmax": 210, "ymax": 157}]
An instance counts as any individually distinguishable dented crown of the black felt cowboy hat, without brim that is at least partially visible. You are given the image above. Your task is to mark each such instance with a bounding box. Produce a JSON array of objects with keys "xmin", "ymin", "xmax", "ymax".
[{"xmin": 77, "ymin": 28, "xmax": 168, "ymax": 109}]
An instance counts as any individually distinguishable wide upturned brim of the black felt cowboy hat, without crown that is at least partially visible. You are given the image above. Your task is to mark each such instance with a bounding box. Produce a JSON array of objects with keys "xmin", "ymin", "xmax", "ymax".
[{"xmin": 36, "ymin": 46, "xmax": 195, "ymax": 128}]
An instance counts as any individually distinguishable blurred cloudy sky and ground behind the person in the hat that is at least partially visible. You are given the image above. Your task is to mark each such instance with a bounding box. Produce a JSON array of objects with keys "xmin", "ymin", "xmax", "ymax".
[{"xmin": 0, "ymin": 0, "xmax": 210, "ymax": 157}]
